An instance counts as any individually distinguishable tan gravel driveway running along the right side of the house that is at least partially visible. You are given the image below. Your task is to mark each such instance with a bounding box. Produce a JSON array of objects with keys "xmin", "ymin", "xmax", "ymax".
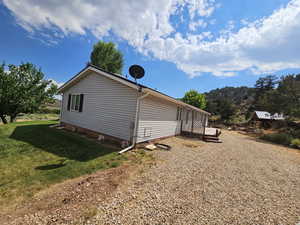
[{"xmin": 86, "ymin": 132, "xmax": 300, "ymax": 225}]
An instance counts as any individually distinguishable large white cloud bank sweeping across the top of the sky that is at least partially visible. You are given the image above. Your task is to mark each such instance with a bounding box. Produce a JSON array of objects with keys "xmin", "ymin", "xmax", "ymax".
[{"xmin": 3, "ymin": 0, "xmax": 300, "ymax": 77}]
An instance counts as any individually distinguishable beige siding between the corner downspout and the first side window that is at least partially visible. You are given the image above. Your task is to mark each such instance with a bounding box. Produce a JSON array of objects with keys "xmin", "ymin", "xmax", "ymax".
[{"xmin": 137, "ymin": 96, "xmax": 180, "ymax": 143}]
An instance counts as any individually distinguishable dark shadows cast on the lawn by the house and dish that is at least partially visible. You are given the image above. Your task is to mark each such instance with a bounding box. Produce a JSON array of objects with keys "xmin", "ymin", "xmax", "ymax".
[{"xmin": 9, "ymin": 124, "xmax": 115, "ymax": 162}]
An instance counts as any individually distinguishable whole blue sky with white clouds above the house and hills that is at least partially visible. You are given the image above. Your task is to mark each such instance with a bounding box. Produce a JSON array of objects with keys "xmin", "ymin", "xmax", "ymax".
[{"xmin": 0, "ymin": 0, "xmax": 300, "ymax": 97}]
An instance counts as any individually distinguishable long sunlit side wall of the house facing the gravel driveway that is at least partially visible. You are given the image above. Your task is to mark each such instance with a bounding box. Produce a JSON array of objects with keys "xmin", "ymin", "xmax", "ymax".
[{"xmin": 137, "ymin": 96, "xmax": 208, "ymax": 143}]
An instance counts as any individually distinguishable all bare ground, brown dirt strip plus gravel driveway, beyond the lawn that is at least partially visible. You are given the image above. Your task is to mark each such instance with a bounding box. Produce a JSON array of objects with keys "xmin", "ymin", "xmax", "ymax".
[{"xmin": 0, "ymin": 131, "xmax": 300, "ymax": 225}]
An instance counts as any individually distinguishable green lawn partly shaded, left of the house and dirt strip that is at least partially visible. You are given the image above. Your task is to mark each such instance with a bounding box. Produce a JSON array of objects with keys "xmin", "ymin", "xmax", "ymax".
[{"xmin": 0, "ymin": 121, "xmax": 126, "ymax": 206}]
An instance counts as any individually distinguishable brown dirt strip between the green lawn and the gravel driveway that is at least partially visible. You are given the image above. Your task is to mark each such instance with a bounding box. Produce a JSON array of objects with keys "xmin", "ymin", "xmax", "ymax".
[{"xmin": 0, "ymin": 150, "xmax": 154, "ymax": 225}]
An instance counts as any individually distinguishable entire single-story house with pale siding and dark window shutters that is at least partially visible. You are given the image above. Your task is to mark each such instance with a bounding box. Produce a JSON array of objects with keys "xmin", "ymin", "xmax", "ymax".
[{"xmin": 59, "ymin": 65, "xmax": 210, "ymax": 147}]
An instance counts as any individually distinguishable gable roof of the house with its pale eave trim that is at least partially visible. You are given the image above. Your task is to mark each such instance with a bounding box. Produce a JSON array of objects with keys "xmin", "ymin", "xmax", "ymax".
[{"xmin": 58, "ymin": 64, "xmax": 210, "ymax": 115}]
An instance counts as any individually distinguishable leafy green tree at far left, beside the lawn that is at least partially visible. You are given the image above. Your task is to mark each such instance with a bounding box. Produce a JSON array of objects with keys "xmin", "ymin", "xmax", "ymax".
[{"xmin": 0, "ymin": 63, "xmax": 57, "ymax": 123}]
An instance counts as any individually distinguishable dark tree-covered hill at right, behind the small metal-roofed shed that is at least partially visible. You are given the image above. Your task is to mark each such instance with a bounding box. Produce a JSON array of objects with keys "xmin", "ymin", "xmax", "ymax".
[{"xmin": 198, "ymin": 74, "xmax": 300, "ymax": 124}]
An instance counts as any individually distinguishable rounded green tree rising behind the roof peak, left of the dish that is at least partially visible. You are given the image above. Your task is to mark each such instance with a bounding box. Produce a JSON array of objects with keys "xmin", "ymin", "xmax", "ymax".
[{"xmin": 90, "ymin": 41, "xmax": 123, "ymax": 74}]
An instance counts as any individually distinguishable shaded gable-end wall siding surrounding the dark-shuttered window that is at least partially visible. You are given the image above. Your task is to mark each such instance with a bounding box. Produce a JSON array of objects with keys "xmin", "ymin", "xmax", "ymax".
[{"xmin": 61, "ymin": 73, "xmax": 137, "ymax": 140}]
